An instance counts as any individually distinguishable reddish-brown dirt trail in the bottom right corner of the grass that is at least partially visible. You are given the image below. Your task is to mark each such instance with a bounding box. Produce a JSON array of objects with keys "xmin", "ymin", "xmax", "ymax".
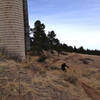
[{"xmin": 80, "ymin": 82, "xmax": 100, "ymax": 100}]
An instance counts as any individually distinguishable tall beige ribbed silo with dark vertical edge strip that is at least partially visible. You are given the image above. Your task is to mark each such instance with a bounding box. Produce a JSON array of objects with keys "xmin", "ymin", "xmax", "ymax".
[{"xmin": 0, "ymin": 0, "xmax": 29, "ymax": 59}]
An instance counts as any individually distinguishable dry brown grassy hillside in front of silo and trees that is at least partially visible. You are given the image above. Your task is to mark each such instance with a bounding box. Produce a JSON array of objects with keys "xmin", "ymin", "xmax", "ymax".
[{"xmin": 0, "ymin": 52, "xmax": 100, "ymax": 100}]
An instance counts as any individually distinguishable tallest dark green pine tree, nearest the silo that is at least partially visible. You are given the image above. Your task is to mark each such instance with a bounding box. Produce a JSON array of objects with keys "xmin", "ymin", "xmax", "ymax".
[{"xmin": 31, "ymin": 20, "xmax": 48, "ymax": 53}]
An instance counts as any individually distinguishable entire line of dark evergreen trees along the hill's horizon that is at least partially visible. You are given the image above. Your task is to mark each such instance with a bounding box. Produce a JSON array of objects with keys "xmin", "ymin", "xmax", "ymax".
[{"xmin": 30, "ymin": 20, "xmax": 100, "ymax": 56}]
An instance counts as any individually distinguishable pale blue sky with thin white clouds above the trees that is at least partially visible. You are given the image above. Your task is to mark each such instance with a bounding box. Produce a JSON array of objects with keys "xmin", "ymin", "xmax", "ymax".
[{"xmin": 28, "ymin": 0, "xmax": 100, "ymax": 50}]
